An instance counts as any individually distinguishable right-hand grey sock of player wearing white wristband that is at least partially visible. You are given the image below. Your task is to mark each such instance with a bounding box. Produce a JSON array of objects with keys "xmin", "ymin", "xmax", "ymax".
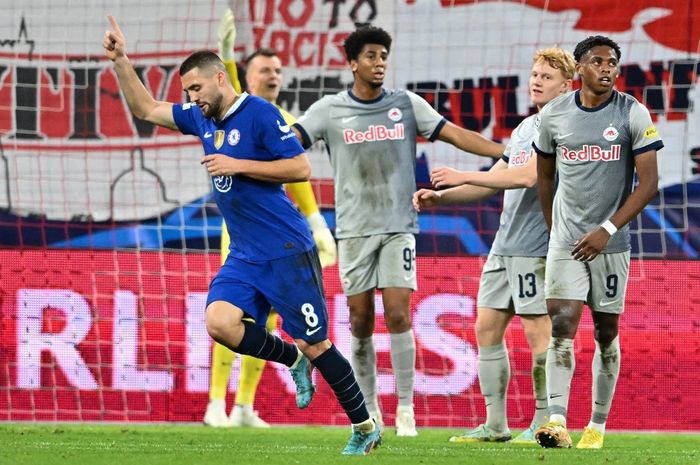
[{"xmin": 591, "ymin": 337, "xmax": 620, "ymax": 424}]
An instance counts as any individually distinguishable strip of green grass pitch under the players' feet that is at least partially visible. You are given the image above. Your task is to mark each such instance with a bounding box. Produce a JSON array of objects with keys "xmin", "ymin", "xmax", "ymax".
[{"xmin": 0, "ymin": 423, "xmax": 700, "ymax": 465}]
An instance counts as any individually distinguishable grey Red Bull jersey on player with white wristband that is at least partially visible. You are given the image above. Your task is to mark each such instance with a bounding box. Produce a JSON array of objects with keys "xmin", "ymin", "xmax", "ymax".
[{"xmin": 533, "ymin": 91, "xmax": 663, "ymax": 253}]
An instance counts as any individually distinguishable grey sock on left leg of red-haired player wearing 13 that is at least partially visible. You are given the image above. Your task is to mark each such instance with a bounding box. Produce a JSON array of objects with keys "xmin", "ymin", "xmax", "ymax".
[{"xmin": 477, "ymin": 342, "xmax": 510, "ymax": 432}]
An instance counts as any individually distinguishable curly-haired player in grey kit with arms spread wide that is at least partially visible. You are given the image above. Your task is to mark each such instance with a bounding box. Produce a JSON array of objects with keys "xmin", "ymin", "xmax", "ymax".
[{"xmin": 294, "ymin": 26, "xmax": 504, "ymax": 436}]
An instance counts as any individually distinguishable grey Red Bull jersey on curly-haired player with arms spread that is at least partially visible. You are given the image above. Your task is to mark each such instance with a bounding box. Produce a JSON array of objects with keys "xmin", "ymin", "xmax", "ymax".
[{"xmin": 295, "ymin": 90, "xmax": 446, "ymax": 239}]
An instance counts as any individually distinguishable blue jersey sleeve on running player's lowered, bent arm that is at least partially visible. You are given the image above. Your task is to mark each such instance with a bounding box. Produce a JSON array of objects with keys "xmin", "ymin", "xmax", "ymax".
[{"xmin": 255, "ymin": 104, "xmax": 304, "ymax": 159}]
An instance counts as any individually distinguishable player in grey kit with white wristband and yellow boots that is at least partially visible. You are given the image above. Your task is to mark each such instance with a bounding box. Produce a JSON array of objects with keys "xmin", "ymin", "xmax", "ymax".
[{"xmin": 533, "ymin": 36, "xmax": 663, "ymax": 449}]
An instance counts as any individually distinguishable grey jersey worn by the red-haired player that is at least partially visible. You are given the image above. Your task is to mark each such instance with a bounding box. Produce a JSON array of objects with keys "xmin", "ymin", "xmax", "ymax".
[{"xmin": 491, "ymin": 115, "xmax": 549, "ymax": 257}]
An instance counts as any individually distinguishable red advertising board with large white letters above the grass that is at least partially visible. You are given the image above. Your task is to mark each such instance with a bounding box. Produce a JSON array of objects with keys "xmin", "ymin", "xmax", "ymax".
[{"xmin": 0, "ymin": 250, "xmax": 700, "ymax": 430}]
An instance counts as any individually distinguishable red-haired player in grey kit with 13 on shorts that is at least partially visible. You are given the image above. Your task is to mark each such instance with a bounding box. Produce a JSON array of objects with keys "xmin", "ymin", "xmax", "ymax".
[{"xmin": 413, "ymin": 48, "xmax": 575, "ymax": 444}]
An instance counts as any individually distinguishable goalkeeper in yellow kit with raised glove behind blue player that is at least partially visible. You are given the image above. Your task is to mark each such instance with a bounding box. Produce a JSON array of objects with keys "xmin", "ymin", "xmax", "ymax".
[{"xmin": 204, "ymin": 10, "xmax": 337, "ymax": 428}]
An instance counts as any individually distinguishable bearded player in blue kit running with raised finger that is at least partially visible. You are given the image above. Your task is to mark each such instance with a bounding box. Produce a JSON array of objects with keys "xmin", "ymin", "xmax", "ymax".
[{"xmin": 103, "ymin": 16, "xmax": 381, "ymax": 455}]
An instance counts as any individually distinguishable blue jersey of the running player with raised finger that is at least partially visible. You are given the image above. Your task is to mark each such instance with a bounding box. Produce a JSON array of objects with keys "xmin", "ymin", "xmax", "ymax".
[{"xmin": 173, "ymin": 93, "xmax": 314, "ymax": 261}]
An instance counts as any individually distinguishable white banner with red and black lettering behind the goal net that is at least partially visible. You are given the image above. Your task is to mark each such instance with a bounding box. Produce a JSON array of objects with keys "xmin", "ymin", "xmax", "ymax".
[{"xmin": 0, "ymin": 0, "xmax": 700, "ymax": 221}]
